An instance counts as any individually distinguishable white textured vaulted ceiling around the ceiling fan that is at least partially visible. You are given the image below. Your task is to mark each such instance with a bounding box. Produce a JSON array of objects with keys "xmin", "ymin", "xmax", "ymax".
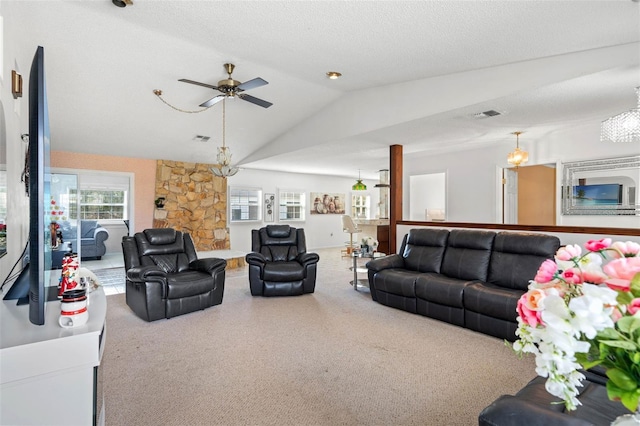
[{"xmin": 5, "ymin": 0, "xmax": 640, "ymax": 178}]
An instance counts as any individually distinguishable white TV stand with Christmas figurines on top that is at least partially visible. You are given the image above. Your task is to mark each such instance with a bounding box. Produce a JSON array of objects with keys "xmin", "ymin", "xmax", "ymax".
[{"xmin": 0, "ymin": 287, "xmax": 107, "ymax": 426}]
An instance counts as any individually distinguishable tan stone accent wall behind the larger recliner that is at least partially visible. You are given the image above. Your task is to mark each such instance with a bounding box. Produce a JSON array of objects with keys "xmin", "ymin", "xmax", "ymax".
[{"xmin": 153, "ymin": 160, "xmax": 230, "ymax": 251}]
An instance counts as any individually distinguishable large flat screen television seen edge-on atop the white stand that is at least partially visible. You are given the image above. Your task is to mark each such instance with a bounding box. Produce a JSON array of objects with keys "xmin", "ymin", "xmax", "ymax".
[{"xmin": 4, "ymin": 46, "xmax": 56, "ymax": 325}]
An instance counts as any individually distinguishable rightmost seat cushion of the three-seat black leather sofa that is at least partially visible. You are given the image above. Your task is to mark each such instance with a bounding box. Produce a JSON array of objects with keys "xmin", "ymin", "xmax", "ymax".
[{"xmin": 464, "ymin": 282, "xmax": 525, "ymax": 322}]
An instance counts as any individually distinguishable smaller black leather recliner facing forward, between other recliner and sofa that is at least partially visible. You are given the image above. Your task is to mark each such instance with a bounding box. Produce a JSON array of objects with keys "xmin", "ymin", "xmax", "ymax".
[{"xmin": 245, "ymin": 225, "xmax": 320, "ymax": 296}]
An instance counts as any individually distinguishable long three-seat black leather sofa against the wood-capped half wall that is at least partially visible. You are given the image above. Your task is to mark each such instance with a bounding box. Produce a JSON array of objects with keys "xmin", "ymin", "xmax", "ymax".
[{"xmin": 367, "ymin": 228, "xmax": 560, "ymax": 341}]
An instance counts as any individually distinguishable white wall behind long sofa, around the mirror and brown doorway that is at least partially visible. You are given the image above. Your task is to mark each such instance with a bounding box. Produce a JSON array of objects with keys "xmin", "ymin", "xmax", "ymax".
[{"xmin": 403, "ymin": 120, "xmax": 640, "ymax": 228}]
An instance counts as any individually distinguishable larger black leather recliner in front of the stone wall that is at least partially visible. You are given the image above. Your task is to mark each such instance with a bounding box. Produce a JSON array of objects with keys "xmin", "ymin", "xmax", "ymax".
[{"xmin": 122, "ymin": 228, "xmax": 227, "ymax": 321}]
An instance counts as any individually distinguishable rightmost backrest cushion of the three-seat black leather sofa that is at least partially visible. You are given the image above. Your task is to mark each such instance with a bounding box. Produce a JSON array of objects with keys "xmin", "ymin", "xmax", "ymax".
[{"xmin": 487, "ymin": 232, "xmax": 560, "ymax": 291}]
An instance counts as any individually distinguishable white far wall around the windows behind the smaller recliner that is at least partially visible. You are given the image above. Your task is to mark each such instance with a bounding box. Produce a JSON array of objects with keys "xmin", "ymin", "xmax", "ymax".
[{"xmin": 227, "ymin": 169, "xmax": 379, "ymax": 252}]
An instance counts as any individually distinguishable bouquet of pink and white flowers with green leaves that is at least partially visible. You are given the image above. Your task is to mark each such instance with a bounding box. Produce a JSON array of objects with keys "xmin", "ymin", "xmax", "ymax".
[{"xmin": 513, "ymin": 238, "xmax": 640, "ymax": 412}]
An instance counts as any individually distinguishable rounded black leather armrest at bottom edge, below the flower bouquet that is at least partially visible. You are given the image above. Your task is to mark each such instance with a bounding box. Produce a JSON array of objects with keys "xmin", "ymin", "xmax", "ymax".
[{"xmin": 478, "ymin": 395, "xmax": 593, "ymax": 426}]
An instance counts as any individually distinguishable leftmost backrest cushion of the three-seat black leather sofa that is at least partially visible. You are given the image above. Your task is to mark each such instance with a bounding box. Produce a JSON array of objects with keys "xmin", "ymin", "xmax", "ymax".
[{"xmin": 402, "ymin": 229, "xmax": 449, "ymax": 273}]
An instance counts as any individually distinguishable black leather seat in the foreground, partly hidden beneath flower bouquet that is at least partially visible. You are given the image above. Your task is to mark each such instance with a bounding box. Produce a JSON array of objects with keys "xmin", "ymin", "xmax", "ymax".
[{"xmin": 478, "ymin": 369, "xmax": 629, "ymax": 426}]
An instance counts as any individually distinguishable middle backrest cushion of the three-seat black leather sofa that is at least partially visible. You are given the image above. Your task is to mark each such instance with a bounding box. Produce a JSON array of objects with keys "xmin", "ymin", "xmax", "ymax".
[{"xmin": 440, "ymin": 229, "xmax": 496, "ymax": 281}]
